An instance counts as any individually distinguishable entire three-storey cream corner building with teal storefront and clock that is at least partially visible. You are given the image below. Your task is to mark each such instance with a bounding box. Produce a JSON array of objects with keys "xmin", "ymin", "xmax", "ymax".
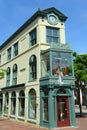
[{"xmin": 0, "ymin": 7, "xmax": 76, "ymax": 128}]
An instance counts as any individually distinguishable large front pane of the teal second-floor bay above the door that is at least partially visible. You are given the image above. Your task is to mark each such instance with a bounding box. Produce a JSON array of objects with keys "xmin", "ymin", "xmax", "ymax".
[{"xmin": 52, "ymin": 52, "xmax": 72, "ymax": 76}]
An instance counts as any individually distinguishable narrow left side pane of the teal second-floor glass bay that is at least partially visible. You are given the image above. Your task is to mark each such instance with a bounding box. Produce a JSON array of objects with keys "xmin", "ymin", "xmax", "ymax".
[{"xmin": 41, "ymin": 53, "xmax": 50, "ymax": 77}]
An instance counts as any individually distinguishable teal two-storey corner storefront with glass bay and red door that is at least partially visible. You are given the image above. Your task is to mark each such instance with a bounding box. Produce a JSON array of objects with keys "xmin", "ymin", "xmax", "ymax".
[{"xmin": 40, "ymin": 45, "xmax": 76, "ymax": 128}]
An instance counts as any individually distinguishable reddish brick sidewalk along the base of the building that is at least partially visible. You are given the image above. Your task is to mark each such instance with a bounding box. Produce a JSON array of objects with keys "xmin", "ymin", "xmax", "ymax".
[{"xmin": 0, "ymin": 117, "xmax": 87, "ymax": 130}]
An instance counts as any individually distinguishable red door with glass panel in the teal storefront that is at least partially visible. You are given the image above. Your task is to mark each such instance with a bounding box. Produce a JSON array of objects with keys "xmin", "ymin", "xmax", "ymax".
[{"xmin": 57, "ymin": 97, "xmax": 70, "ymax": 127}]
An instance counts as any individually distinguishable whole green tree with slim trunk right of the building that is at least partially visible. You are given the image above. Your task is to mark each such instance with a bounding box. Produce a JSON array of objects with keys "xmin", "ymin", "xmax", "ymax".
[{"xmin": 73, "ymin": 52, "xmax": 87, "ymax": 116}]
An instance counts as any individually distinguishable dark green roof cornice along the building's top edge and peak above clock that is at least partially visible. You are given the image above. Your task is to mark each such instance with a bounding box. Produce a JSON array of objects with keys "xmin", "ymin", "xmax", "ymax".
[{"xmin": 0, "ymin": 7, "xmax": 67, "ymax": 50}]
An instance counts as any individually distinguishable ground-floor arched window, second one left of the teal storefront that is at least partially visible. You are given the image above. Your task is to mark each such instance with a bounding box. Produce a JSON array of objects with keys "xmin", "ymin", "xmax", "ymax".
[{"xmin": 19, "ymin": 90, "xmax": 25, "ymax": 117}]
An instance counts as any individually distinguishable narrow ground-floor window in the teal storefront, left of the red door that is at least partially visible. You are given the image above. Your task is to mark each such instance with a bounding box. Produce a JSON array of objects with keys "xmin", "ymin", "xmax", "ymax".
[{"xmin": 43, "ymin": 98, "xmax": 48, "ymax": 121}]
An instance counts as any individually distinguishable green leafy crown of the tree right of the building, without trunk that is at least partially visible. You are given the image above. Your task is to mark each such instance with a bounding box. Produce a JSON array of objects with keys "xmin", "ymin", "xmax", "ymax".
[{"xmin": 73, "ymin": 52, "xmax": 87, "ymax": 84}]
